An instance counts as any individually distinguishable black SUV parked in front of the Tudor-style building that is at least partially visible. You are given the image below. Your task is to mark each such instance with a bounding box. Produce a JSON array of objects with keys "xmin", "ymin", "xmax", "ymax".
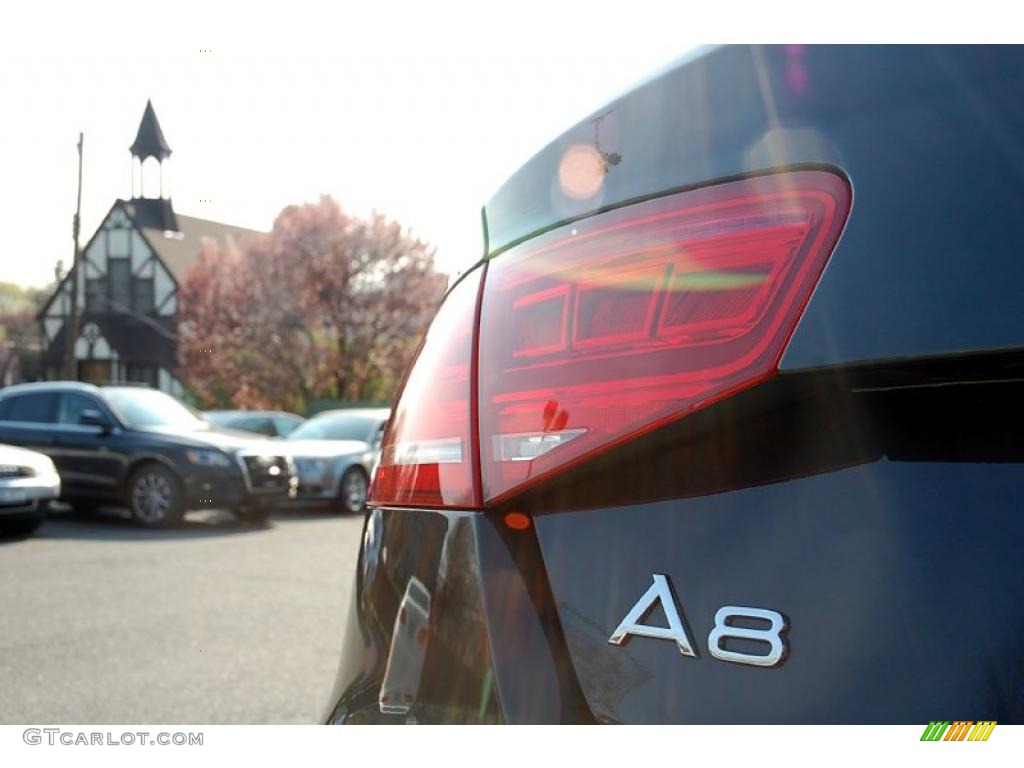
[{"xmin": 0, "ymin": 382, "xmax": 295, "ymax": 527}]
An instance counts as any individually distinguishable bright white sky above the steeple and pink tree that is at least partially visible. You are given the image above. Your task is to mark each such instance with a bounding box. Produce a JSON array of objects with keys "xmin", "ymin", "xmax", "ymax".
[{"xmin": 0, "ymin": 0, "xmax": 697, "ymax": 286}]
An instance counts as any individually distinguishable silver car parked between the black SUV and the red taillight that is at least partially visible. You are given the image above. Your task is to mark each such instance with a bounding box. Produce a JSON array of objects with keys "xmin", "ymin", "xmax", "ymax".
[{"xmin": 281, "ymin": 409, "xmax": 391, "ymax": 513}]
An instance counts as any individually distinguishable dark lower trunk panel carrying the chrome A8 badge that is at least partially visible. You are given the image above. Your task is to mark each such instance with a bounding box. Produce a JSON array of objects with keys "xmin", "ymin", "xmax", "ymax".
[{"xmin": 537, "ymin": 444, "xmax": 1024, "ymax": 723}]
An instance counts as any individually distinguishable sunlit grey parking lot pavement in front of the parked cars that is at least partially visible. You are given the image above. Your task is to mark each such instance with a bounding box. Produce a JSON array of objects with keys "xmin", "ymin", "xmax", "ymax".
[{"xmin": 0, "ymin": 511, "xmax": 362, "ymax": 724}]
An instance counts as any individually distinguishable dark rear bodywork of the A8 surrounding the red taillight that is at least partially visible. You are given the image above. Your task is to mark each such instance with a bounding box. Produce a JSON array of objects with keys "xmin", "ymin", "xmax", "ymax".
[{"xmin": 332, "ymin": 46, "xmax": 1024, "ymax": 723}]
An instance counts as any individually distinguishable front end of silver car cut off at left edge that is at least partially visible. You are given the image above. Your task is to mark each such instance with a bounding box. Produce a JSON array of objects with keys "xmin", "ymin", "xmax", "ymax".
[{"xmin": 0, "ymin": 445, "xmax": 60, "ymax": 535}]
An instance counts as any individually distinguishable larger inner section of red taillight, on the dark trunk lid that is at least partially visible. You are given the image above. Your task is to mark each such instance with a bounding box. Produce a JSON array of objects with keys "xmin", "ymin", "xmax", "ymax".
[{"xmin": 475, "ymin": 171, "xmax": 850, "ymax": 503}]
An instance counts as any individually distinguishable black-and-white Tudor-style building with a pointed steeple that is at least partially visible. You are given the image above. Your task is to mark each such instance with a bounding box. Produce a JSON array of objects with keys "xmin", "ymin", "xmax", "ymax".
[{"xmin": 39, "ymin": 101, "xmax": 257, "ymax": 394}]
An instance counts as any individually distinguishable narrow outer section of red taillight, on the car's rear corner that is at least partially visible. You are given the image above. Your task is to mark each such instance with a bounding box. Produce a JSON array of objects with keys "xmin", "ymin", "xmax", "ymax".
[{"xmin": 370, "ymin": 268, "xmax": 483, "ymax": 507}]
